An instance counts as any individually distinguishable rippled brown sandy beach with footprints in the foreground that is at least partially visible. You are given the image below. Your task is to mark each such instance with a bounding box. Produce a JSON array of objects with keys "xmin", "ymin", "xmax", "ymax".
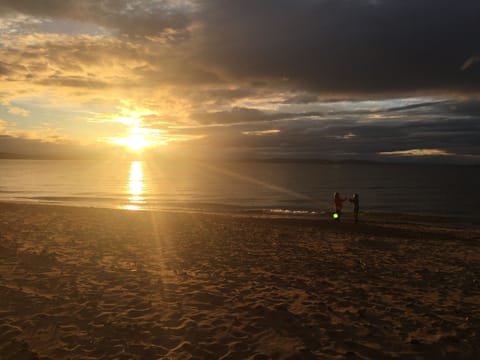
[{"xmin": 0, "ymin": 204, "xmax": 480, "ymax": 359}]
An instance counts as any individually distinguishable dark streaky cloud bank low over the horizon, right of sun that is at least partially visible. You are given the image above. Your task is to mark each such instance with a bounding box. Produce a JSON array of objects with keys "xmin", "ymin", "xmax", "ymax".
[{"xmin": 179, "ymin": 100, "xmax": 480, "ymax": 160}]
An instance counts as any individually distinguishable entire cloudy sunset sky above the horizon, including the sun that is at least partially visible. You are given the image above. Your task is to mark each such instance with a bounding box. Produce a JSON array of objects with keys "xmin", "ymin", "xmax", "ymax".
[{"xmin": 0, "ymin": 0, "xmax": 480, "ymax": 164}]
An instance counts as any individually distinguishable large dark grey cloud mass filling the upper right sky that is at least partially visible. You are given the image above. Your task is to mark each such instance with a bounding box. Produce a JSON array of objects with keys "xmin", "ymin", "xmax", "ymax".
[{"xmin": 198, "ymin": 0, "xmax": 480, "ymax": 96}]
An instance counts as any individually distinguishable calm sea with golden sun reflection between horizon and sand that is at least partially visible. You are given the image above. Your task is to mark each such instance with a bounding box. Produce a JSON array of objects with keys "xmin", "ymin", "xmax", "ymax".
[{"xmin": 0, "ymin": 159, "xmax": 480, "ymax": 223}]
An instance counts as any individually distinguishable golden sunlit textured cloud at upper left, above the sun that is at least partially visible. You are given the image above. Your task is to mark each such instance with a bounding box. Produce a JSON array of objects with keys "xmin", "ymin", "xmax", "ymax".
[{"xmin": 0, "ymin": 30, "xmax": 221, "ymax": 108}]
